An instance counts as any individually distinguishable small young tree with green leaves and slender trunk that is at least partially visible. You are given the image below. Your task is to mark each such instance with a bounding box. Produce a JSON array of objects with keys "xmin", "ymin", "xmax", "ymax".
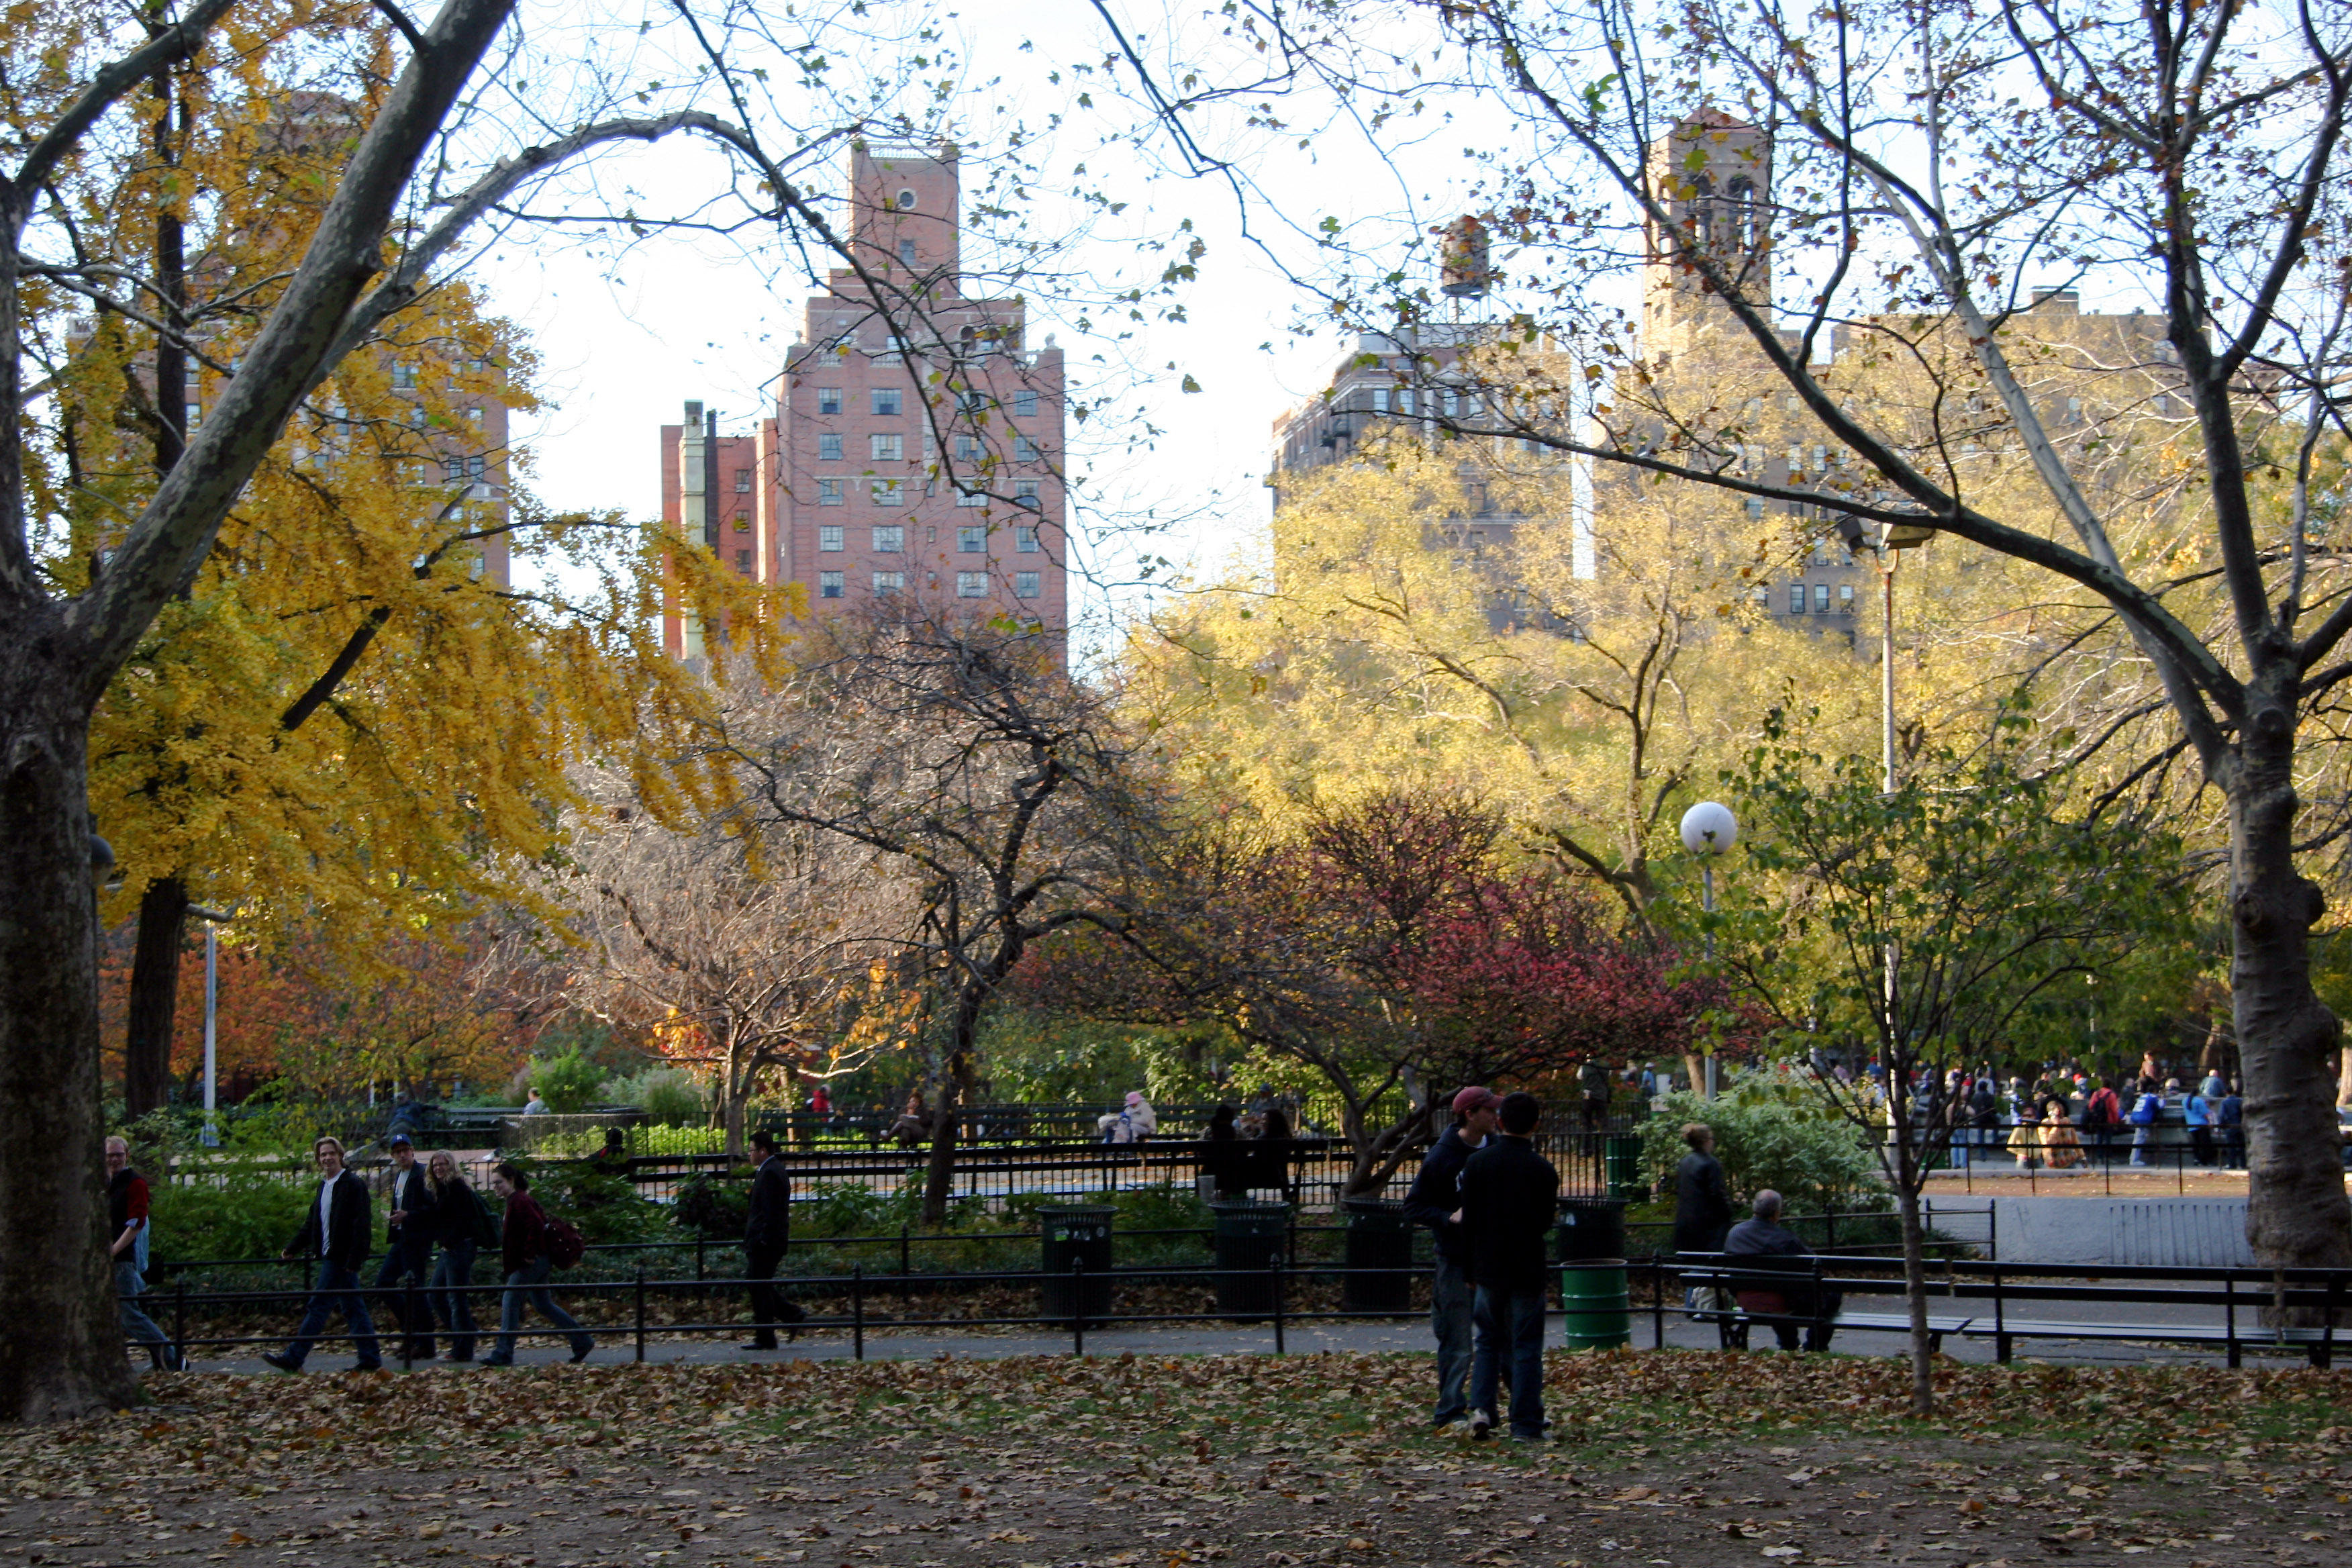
[{"xmin": 1717, "ymin": 710, "xmax": 2188, "ymax": 1415}]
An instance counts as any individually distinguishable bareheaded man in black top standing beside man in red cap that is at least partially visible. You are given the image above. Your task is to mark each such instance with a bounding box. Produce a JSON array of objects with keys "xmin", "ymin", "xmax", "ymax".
[{"xmin": 1461, "ymin": 1093, "xmax": 1559, "ymax": 1443}]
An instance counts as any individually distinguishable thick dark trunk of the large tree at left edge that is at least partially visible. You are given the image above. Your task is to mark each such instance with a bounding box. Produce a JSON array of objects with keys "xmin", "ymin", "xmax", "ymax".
[{"xmin": 0, "ymin": 681, "xmax": 134, "ymax": 1422}]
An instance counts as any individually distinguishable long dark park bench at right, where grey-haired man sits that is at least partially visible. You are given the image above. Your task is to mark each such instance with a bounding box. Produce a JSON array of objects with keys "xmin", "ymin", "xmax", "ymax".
[{"xmin": 1677, "ymin": 1253, "xmax": 2352, "ymax": 1368}]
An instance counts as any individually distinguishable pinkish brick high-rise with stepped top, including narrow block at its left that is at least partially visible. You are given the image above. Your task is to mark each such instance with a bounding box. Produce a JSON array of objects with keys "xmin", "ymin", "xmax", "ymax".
[{"xmin": 661, "ymin": 144, "xmax": 1068, "ymax": 658}]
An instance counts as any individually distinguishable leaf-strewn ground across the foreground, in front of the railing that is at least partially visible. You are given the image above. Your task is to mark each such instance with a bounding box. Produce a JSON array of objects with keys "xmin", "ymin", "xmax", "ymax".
[{"xmin": 0, "ymin": 1352, "xmax": 2352, "ymax": 1568}]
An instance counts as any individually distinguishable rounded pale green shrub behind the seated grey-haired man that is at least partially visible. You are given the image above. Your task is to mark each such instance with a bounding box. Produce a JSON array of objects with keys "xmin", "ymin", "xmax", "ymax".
[{"xmin": 1642, "ymin": 1067, "xmax": 1886, "ymax": 1213}]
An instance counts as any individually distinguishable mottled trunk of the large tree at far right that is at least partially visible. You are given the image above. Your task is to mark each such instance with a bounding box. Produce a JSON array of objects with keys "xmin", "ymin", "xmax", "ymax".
[{"xmin": 2230, "ymin": 738, "xmax": 2352, "ymax": 1269}]
